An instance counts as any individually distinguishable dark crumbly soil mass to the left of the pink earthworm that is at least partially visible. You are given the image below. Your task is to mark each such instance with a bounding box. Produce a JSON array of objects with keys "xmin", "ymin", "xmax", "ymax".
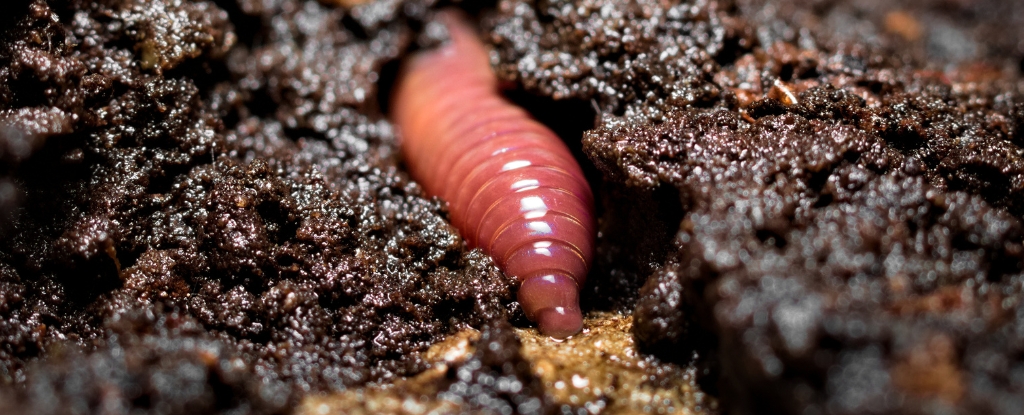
[{"xmin": 0, "ymin": 0, "xmax": 516, "ymax": 414}]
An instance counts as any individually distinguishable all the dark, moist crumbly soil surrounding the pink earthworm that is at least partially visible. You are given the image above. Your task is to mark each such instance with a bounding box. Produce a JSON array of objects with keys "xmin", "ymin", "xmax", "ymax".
[{"xmin": 0, "ymin": 0, "xmax": 1024, "ymax": 414}]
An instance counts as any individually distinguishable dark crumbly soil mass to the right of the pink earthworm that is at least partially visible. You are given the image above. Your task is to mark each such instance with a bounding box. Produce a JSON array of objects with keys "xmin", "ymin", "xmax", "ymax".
[{"xmin": 486, "ymin": 1, "xmax": 1024, "ymax": 414}]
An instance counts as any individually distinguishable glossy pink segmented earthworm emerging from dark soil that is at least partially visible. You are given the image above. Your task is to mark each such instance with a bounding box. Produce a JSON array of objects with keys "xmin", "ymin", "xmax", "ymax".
[{"xmin": 392, "ymin": 13, "xmax": 596, "ymax": 338}]
